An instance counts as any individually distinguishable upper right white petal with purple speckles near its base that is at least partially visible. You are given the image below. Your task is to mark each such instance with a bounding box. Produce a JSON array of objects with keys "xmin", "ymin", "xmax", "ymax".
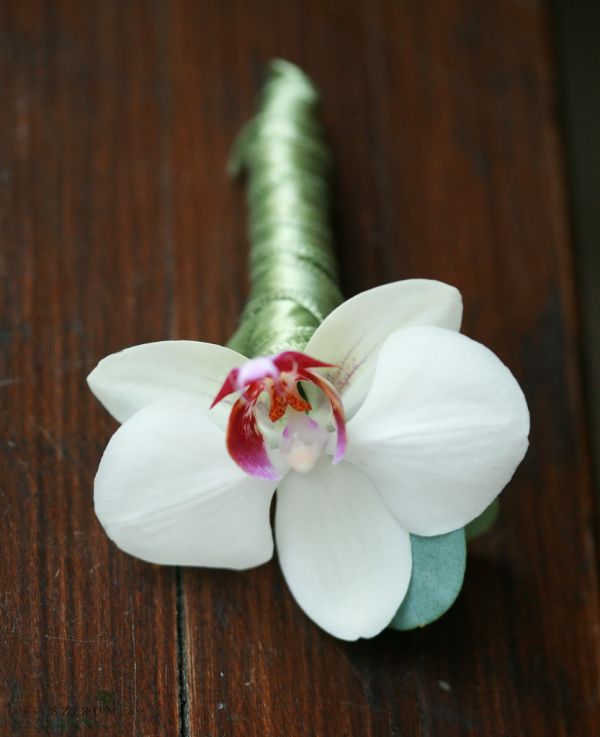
[{"xmin": 305, "ymin": 279, "xmax": 462, "ymax": 419}]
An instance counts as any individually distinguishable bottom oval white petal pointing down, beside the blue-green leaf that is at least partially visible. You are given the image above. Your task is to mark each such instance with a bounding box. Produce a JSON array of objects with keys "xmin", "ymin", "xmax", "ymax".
[{"xmin": 275, "ymin": 458, "xmax": 411, "ymax": 640}]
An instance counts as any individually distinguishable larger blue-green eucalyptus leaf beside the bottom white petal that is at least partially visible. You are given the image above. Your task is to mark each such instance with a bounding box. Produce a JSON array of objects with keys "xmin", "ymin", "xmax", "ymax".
[{"xmin": 388, "ymin": 528, "xmax": 467, "ymax": 630}]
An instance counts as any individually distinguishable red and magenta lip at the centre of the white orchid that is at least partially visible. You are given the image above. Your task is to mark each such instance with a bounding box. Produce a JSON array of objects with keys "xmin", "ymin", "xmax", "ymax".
[{"xmin": 211, "ymin": 351, "xmax": 346, "ymax": 480}]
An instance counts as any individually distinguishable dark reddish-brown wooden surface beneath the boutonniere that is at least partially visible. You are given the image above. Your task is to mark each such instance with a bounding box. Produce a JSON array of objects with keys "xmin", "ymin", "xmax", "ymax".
[{"xmin": 0, "ymin": 0, "xmax": 600, "ymax": 737}]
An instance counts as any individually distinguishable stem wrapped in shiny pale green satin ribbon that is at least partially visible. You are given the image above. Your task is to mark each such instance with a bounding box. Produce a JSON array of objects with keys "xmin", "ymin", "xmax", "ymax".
[{"xmin": 228, "ymin": 60, "xmax": 342, "ymax": 356}]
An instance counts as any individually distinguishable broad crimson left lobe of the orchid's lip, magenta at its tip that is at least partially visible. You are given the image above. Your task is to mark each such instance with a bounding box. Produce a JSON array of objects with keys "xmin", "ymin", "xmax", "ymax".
[{"xmin": 227, "ymin": 385, "xmax": 280, "ymax": 480}]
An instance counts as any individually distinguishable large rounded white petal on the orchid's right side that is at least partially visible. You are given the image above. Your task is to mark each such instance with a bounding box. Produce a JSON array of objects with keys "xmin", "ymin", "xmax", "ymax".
[{"xmin": 346, "ymin": 327, "xmax": 529, "ymax": 536}]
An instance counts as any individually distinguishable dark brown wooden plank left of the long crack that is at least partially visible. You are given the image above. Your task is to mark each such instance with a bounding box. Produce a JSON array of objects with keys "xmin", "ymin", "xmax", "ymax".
[{"xmin": 0, "ymin": 2, "xmax": 179, "ymax": 737}]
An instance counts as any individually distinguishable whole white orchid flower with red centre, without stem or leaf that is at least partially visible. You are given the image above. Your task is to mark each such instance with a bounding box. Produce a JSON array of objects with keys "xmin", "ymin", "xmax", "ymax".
[{"xmin": 88, "ymin": 279, "xmax": 529, "ymax": 640}]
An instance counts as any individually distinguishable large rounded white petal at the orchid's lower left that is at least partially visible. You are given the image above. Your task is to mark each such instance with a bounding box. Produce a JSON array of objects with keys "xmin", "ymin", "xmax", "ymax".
[{"xmin": 94, "ymin": 400, "xmax": 275, "ymax": 569}]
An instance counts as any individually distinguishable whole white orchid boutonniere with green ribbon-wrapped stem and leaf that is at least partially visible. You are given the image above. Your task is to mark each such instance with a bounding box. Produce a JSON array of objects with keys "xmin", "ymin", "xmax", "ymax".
[{"xmin": 88, "ymin": 61, "xmax": 529, "ymax": 640}]
